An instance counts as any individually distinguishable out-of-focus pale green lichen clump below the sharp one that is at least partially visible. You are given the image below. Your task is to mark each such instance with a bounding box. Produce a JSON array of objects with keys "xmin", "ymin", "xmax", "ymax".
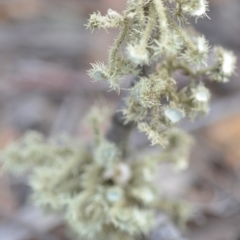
[{"xmin": 1, "ymin": 132, "xmax": 188, "ymax": 240}]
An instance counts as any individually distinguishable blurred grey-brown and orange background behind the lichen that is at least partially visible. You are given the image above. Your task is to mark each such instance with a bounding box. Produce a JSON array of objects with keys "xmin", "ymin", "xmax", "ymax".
[{"xmin": 0, "ymin": 0, "xmax": 240, "ymax": 240}]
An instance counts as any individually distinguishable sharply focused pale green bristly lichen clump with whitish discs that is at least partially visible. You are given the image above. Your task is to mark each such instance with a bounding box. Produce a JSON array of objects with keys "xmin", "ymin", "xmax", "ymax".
[{"xmin": 87, "ymin": 0, "xmax": 236, "ymax": 146}]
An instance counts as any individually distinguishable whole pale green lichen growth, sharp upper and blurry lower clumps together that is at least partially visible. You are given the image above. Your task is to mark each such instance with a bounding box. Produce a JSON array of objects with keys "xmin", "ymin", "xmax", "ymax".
[{"xmin": 1, "ymin": 0, "xmax": 236, "ymax": 240}]
